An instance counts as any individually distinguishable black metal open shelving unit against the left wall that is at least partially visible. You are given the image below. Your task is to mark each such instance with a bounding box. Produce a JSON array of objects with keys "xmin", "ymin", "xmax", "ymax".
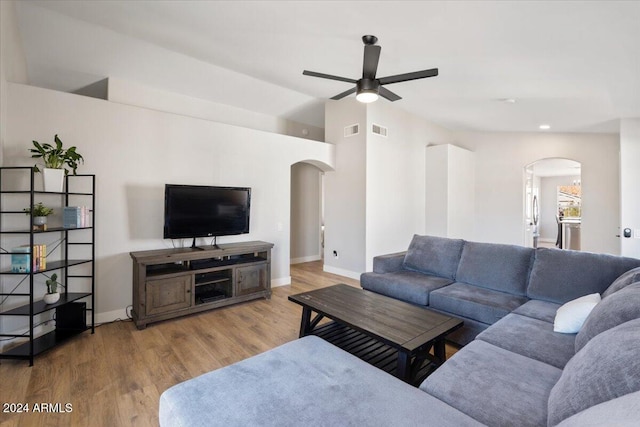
[{"xmin": 0, "ymin": 167, "xmax": 96, "ymax": 366}]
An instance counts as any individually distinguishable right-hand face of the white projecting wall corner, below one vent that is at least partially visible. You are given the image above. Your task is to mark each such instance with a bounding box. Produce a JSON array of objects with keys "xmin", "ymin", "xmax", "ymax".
[{"xmin": 361, "ymin": 100, "xmax": 451, "ymax": 271}]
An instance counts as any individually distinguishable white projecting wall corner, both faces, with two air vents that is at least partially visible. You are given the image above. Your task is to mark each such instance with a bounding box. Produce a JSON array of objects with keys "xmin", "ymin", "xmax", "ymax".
[{"xmin": 324, "ymin": 98, "xmax": 451, "ymax": 277}]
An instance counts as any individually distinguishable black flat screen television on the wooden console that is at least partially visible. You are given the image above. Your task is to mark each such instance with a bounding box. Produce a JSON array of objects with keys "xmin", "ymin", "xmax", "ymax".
[{"xmin": 164, "ymin": 184, "xmax": 251, "ymax": 247}]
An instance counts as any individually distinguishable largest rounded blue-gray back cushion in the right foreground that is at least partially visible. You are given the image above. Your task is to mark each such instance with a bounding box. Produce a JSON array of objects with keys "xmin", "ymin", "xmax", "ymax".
[{"xmin": 548, "ymin": 319, "xmax": 640, "ymax": 426}]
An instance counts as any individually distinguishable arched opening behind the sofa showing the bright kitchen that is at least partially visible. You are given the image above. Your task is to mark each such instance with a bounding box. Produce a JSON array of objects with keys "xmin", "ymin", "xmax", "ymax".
[{"xmin": 524, "ymin": 158, "xmax": 583, "ymax": 250}]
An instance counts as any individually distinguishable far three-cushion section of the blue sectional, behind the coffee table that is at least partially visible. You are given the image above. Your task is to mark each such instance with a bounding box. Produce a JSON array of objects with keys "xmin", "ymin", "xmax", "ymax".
[{"xmin": 360, "ymin": 235, "xmax": 640, "ymax": 345}]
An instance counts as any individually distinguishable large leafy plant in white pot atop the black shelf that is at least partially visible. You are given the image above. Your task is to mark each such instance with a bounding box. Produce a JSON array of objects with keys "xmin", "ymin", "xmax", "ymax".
[{"xmin": 29, "ymin": 135, "xmax": 84, "ymax": 193}]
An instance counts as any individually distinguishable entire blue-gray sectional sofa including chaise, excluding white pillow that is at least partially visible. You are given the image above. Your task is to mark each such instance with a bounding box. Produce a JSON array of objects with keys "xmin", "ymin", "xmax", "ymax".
[{"xmin": 160, "ymin": 236, "xmax": 640, "ymax": 427}]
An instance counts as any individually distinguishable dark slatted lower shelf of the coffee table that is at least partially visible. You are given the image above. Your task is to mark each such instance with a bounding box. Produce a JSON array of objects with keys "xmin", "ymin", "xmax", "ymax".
[{"xmin": 310, "ymin": 321, "xmax": 440, "ymax": 387}]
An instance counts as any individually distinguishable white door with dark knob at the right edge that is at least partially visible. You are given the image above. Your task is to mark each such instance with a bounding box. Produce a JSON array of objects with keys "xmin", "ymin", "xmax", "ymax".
[{"xmin": 619, "ymin": 118, "xmax": 640, "ymax": 258}]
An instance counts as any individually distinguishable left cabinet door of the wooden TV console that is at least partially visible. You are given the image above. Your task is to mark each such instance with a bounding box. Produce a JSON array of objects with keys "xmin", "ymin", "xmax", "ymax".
[{"xmin": 145, "ymin": 275, "xmax": 192, "ymax": 316}]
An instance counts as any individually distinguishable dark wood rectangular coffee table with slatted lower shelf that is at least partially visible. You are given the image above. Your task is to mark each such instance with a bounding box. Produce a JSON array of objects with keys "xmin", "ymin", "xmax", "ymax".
[{"xmin": 289, "ymin": 284, "xmax": 463, "ymax": 385}]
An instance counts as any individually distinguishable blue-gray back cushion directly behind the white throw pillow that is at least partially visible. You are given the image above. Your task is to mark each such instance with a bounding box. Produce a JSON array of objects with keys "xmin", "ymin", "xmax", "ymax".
[{"xmin": 576, "ymin": 282, "xmax": 640, "ymax": 353}]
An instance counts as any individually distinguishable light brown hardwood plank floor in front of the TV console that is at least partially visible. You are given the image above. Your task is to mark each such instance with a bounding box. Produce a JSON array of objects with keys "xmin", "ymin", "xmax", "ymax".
[{"xmin": 0, "ymin": 262, "xmax": 455, "ymax": 427}]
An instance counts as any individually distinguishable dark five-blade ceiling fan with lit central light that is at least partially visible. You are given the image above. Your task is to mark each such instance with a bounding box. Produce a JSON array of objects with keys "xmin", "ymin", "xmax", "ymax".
[{"xmin": 302, "ymin": 35, "xmax": 438, "ymax": 102}]
